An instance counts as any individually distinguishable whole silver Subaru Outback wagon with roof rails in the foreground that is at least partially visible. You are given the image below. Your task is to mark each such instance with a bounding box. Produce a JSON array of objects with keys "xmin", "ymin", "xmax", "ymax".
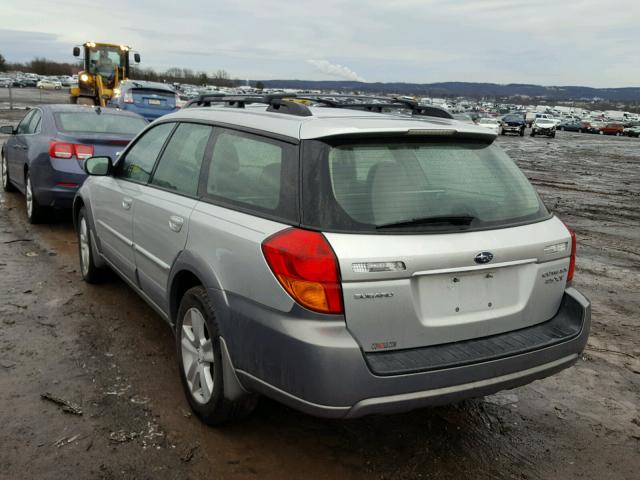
[{"xmin": 73, "ymin": 96, "xmax": 591, "ymax": 424}]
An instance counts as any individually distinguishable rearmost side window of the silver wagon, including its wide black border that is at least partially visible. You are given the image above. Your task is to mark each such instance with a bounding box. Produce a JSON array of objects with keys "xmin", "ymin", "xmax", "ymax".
[{"xmin": 206, "ymin": 129, "xmax": 298, "ymax": 220}]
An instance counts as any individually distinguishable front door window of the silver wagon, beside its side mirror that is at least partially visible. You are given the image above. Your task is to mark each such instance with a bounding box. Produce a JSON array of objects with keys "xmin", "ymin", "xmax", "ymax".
[{"xmin": 118, "ymin": 123, "xmax": 175, "ymax": 183}]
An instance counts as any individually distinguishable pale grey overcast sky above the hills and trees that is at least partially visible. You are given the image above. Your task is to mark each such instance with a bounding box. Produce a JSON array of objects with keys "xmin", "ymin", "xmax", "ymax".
[{"xmin": 0, "ymin": 0, "xmax": 640, "ymax": 87}]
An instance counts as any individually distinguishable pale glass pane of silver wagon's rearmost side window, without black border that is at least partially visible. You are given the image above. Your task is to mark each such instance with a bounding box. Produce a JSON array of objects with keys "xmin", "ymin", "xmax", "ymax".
[{"xmin": 207, "ymin": 130, "xmax": 284, "ymax": 211}]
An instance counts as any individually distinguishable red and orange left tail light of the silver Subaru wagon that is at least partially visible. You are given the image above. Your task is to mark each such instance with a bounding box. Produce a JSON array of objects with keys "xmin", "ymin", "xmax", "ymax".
[{"xmin": 262, "ymin": 228, "xmax": 344, "ymax": 314}]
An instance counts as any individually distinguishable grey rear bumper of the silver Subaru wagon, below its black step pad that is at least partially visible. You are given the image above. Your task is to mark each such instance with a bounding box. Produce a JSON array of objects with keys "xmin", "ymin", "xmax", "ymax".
[{"xmin": 222, "ymin": 288, "xmax": 591, "ymax": 418}]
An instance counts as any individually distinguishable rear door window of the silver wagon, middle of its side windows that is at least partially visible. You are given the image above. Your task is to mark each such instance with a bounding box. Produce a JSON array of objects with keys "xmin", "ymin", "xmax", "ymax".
[{"xmin": 151, "ymin": 123, "xmax": 213, "ymax": 196}]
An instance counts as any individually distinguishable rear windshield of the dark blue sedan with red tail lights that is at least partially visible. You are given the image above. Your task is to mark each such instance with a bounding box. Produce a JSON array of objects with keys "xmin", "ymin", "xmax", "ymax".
[{"xmin": 55, "ymin": 110, "xmax": 147, "ymax": 136}]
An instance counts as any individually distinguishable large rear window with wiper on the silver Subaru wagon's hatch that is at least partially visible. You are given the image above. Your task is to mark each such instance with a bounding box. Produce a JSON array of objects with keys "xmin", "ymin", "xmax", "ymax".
[{"xmin": 303, "ymin": 139, "xmax": 549, "ymax": 233}]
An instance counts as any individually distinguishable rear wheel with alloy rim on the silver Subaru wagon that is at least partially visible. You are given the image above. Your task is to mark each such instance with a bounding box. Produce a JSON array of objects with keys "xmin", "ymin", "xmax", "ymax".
[{"xmin": 176, "ymin": 287, "xmax": 256, "ymax": 425}]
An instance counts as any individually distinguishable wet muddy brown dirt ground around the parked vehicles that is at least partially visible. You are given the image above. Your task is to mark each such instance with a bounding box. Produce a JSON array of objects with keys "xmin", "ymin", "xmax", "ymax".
[{"xmin": 0, "ymin": 90, "xmax": 640, "ymax": 479}]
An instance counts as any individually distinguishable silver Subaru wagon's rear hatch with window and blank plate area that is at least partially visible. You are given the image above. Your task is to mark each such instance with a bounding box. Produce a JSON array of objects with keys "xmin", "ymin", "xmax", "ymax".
[{"xmin": 303, "ymin": 138, "xmax": 571, "ymax": 351}]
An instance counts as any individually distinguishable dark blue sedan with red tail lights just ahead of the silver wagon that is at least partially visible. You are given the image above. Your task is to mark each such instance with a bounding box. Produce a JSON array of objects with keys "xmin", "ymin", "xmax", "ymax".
[{"xmin": 0, "ymin": 105, "xmax": 147, "ymax": 223}]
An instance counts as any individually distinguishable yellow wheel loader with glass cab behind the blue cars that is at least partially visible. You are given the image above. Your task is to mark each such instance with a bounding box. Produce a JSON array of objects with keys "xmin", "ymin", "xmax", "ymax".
[{"xmin": 69, "ymin": 42, "xmax": 140, "ymax": 107}]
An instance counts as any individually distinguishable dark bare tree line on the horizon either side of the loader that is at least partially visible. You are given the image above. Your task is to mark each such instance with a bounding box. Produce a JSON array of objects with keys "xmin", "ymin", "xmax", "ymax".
[{"xmin": 0, "ymin": 54, "xmax": 250, "ymax": 87}]
